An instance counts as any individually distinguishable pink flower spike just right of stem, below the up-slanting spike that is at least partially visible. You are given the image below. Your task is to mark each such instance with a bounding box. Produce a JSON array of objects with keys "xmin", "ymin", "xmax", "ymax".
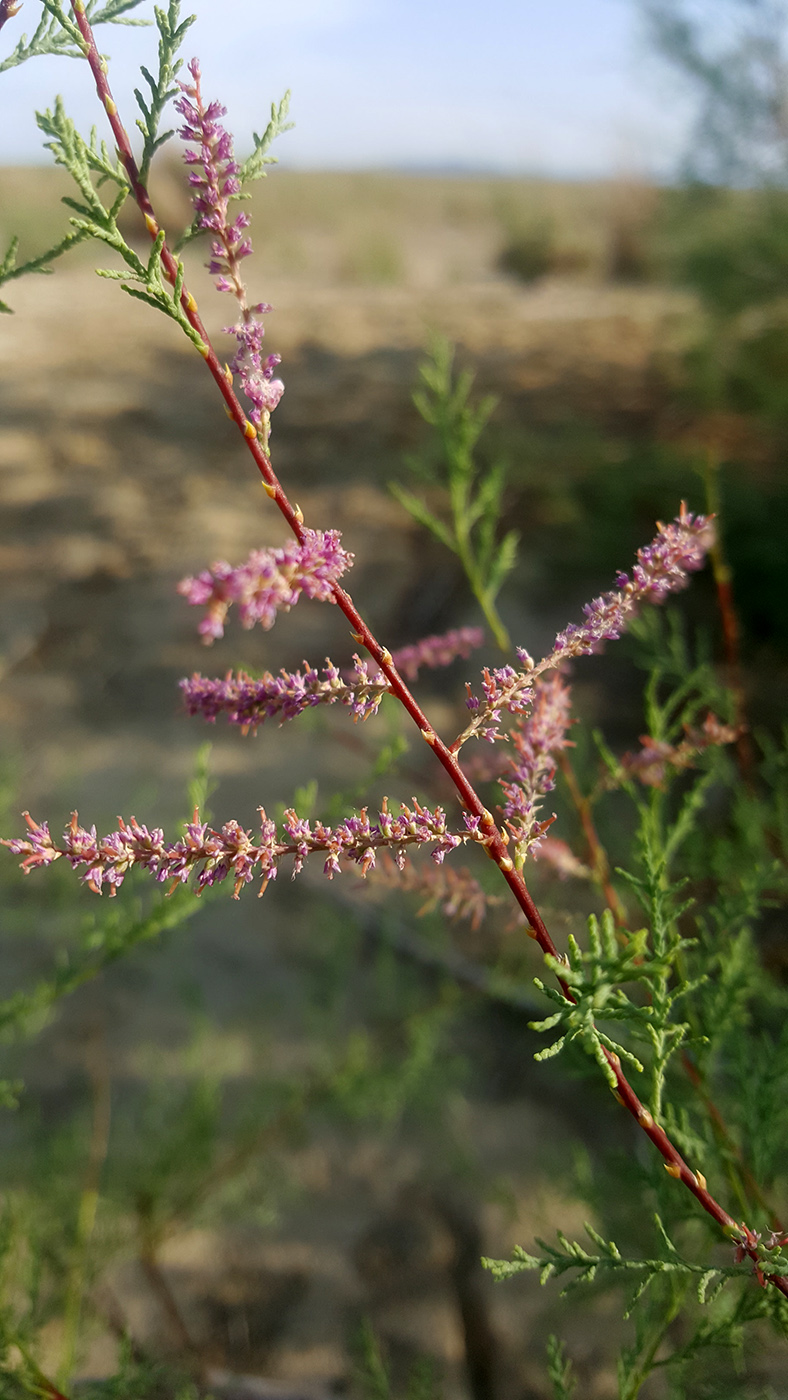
[{"xmin": 501, "ymin": 672, "xmax": 571, "ymax": 858}]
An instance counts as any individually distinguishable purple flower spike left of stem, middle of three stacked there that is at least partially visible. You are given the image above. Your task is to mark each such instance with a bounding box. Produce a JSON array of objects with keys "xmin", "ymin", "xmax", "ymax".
[{"xmin": 181, "ymin": 657, "xmax": 389, "ymax": 732}]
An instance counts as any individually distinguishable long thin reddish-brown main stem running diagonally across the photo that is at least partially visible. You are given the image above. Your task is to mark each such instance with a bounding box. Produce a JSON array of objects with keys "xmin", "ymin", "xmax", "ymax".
[{"xmin": 71, "ymin": 0, "xmax": 788, "ymax": 1296}]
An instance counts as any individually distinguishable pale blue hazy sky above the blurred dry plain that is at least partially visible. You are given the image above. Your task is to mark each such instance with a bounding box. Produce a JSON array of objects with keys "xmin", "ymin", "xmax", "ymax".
[{"xmin": 0, "ymin": 0, "xmax": 689, "ymax": 176}]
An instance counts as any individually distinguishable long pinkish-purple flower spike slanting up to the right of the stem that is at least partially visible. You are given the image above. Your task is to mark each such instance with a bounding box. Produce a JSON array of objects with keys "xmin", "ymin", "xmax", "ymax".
[{"xmin": 453, "ymin": 501, "xmax": 714, "ymax": 752}]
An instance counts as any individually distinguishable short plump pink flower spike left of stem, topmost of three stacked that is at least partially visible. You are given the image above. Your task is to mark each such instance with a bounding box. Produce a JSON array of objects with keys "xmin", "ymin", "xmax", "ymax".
[{"xmin": 178, "ymin": 529, "xmax": 354, "ymax": 647}]
